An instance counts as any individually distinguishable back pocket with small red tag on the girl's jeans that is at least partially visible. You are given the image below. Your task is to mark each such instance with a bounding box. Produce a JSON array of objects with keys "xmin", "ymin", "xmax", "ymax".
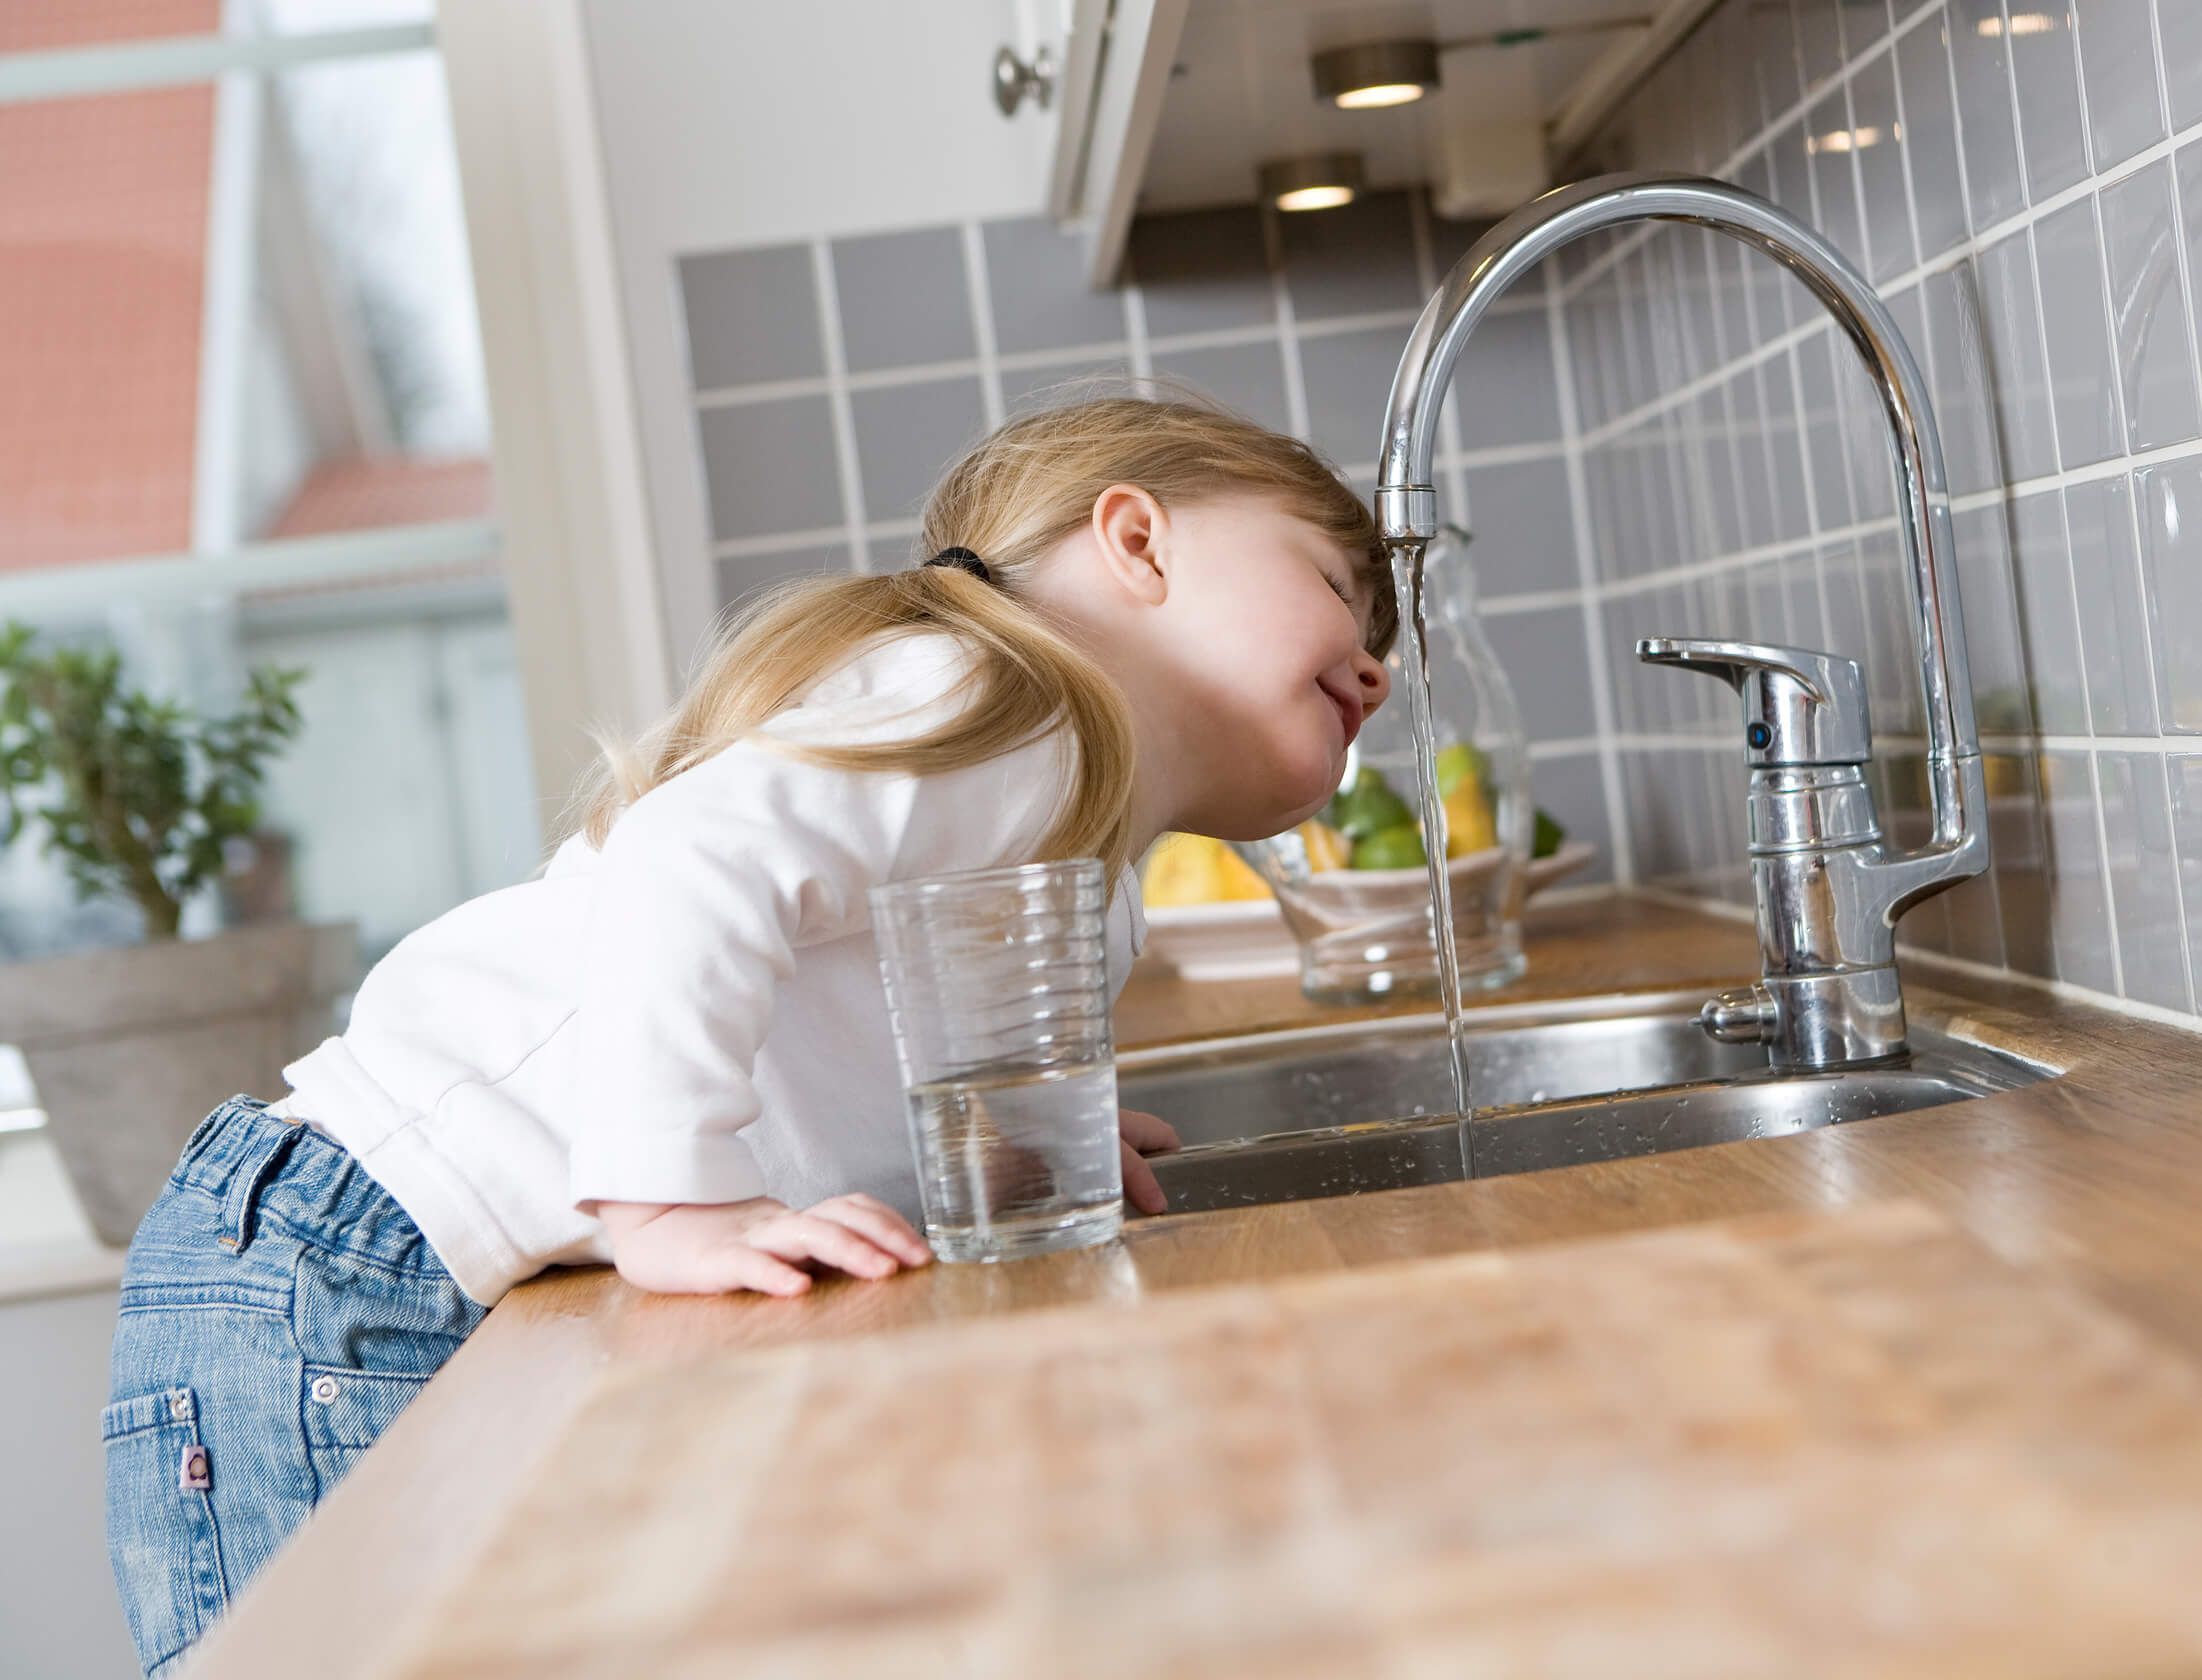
[{"xmin": 99, "ymin": 1387, "xmax": 229, "ymax": 1673}]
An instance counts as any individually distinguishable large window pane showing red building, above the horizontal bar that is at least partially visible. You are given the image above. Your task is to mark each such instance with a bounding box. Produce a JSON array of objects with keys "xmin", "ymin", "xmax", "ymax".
[{"xmin": 0, "ymin": 51, "xmax": 491, "ymax": 572}]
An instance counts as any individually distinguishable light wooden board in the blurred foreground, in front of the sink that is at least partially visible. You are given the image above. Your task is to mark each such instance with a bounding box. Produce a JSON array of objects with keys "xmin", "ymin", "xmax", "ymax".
[{"xmin": 394, "ymin": 1202, "xmax": 2202, "ymax": 1680}]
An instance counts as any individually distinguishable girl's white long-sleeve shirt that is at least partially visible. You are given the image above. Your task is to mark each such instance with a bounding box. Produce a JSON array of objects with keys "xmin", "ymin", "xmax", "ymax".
[{"xmin": 282, "ymin": 634, "xmax": 1145, "ymax": 1303}]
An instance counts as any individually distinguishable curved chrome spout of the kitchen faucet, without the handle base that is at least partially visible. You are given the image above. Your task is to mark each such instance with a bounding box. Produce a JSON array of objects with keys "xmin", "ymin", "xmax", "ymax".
[{"xmin": 1376, "ymin": 174, "xmax": 1984, "ymax": 841}]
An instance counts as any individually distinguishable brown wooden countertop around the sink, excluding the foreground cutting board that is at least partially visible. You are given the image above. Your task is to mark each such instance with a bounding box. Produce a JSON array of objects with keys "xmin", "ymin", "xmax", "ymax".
[{"xmin": 194, "ymin": 896, "xmax": 2202, "ymax": 1676}]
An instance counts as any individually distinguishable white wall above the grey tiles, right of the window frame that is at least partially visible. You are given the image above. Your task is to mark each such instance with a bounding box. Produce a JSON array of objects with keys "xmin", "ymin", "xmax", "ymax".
[{"xmin": 581, "ymin": 0, "xmax": 1061, "ymax": 678}]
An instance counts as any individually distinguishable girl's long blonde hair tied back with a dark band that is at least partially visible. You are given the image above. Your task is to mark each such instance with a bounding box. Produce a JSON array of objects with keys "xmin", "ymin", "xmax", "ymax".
[{"xmin": 581, "ymin": 396, "xmax": 1396, "ymax": 881}]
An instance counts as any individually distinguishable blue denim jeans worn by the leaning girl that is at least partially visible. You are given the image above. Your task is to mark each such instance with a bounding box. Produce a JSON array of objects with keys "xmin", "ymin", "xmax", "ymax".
[{"xmin": 101, "ymin": 1097, "xmax": 487, "ymax": 1676}]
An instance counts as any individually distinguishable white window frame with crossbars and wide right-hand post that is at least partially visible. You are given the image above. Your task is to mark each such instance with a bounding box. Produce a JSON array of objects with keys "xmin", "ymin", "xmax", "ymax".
[{"xmin": 0, "ymin": 0, "xmax": 674, "ymax": 812}]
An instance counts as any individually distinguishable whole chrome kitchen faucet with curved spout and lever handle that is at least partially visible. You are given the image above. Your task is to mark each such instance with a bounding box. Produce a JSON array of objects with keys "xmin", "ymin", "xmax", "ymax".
[{"xmin": 1376, "ymin": 174, "xmax": 1988, "ymax": 1070}]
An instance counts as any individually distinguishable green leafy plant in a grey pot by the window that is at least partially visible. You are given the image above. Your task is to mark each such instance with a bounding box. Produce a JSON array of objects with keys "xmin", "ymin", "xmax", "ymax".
[{"xmin": 0, "ymin": 625, "xmax": 357, "ymax": 1244}]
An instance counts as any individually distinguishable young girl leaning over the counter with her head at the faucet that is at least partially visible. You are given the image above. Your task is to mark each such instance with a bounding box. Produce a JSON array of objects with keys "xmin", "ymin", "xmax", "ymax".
[{"xmin": 103, "ymin": 396, "xmax": 1394, "ymax": 1673}]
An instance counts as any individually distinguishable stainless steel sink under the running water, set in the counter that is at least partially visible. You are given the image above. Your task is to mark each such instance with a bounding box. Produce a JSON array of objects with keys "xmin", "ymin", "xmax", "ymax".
[{"xmin": 1119, "ymin": 993, "xmax": 2054, "ymax": 1213}]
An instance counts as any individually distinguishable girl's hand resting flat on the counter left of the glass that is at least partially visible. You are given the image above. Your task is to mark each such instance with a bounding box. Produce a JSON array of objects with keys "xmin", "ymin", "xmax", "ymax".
[{"xmin": 597, "ymin": 1197, "xmax": 929, "ymax": 1295}]
